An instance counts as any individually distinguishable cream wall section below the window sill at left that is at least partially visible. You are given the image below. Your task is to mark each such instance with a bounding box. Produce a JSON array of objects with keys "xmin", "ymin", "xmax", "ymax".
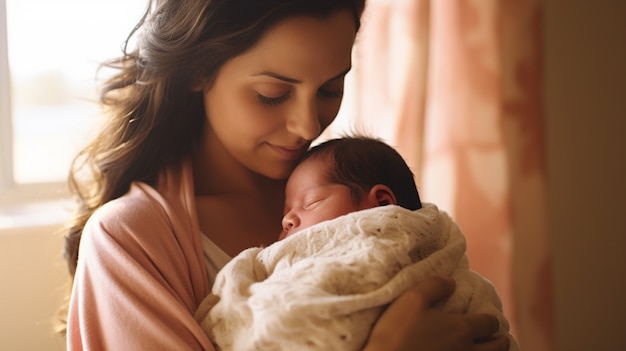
[{"xmin": 0, "ymin": 225, "xmax": 67, "ymax": 351}]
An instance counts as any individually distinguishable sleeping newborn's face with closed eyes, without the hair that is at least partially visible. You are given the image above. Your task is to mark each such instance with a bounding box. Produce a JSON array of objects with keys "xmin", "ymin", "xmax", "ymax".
[{"xmin": 280, "ymin": 158, "xmax": 369, "ymax": 239}]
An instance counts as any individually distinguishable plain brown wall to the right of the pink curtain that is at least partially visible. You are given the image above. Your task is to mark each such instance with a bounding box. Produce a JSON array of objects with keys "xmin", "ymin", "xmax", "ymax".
[{"xmin": 544, "ymin": 0, "xmax": 626, "ymax": 351}]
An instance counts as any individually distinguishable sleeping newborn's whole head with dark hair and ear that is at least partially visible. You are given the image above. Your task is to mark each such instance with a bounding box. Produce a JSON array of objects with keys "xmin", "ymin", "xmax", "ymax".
[{"xmin": 281, "ymin": 137, "xmax": 422, "ymax": 238}]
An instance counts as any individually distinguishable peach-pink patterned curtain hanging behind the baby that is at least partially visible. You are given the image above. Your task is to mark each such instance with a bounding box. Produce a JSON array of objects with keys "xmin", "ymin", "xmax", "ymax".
[{"xmin": 350, "ymin": 0, "xmax": 553, "ymax": 351}]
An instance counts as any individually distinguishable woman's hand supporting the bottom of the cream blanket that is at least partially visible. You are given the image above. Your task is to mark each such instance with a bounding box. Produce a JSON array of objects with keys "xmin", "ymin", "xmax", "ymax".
[{"xmin": 364, "ymin": 277, "xmax": 509, "ymax": 351}]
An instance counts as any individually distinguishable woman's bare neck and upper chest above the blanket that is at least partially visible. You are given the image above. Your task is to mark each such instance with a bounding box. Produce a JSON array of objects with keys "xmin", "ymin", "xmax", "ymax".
[{"xmin": 193, "ymin": 132, "xmax": 286, "ymax": 256}]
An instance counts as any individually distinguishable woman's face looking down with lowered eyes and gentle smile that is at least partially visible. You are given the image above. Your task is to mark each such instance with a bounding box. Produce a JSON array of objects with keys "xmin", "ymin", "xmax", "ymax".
[{"xmin": 203, "ymin": 11, "xmax": 356, "ymax": 179}]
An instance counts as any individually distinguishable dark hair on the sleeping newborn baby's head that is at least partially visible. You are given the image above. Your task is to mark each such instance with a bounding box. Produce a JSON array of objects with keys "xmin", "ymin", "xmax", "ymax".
[{"xmin": 301, "ymin": 136, "xmax": 422, "ymax": 210}]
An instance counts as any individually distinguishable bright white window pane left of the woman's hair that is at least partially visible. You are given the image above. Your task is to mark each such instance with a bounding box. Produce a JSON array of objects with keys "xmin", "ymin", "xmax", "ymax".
[{"xmin": 6, "ymin": 0, "xmax": 146, "ymax": 183}]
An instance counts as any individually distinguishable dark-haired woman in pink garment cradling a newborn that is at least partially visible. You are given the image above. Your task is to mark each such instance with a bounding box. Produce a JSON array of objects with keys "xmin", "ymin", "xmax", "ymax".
[{"xmin": 66, "ymin": 0, "xmax": 507, "ymax": 350}]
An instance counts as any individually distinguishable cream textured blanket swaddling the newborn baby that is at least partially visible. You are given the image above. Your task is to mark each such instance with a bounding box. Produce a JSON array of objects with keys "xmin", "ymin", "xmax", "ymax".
[{"xmin": 196, "ymin": 204, "xmax": 517, "ymax": 351}]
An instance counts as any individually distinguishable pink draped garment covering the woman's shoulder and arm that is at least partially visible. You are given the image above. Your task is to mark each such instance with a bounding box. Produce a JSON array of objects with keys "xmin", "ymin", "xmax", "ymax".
[{"xmin": 67, "ymin": 163, "xmax": 213, "ymax": 350}]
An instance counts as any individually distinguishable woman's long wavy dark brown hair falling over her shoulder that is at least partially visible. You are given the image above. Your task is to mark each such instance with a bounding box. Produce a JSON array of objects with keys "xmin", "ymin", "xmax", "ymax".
[{"xmin": 61, "ymin": 0, "xmax": 365, "ymax": 331}]
